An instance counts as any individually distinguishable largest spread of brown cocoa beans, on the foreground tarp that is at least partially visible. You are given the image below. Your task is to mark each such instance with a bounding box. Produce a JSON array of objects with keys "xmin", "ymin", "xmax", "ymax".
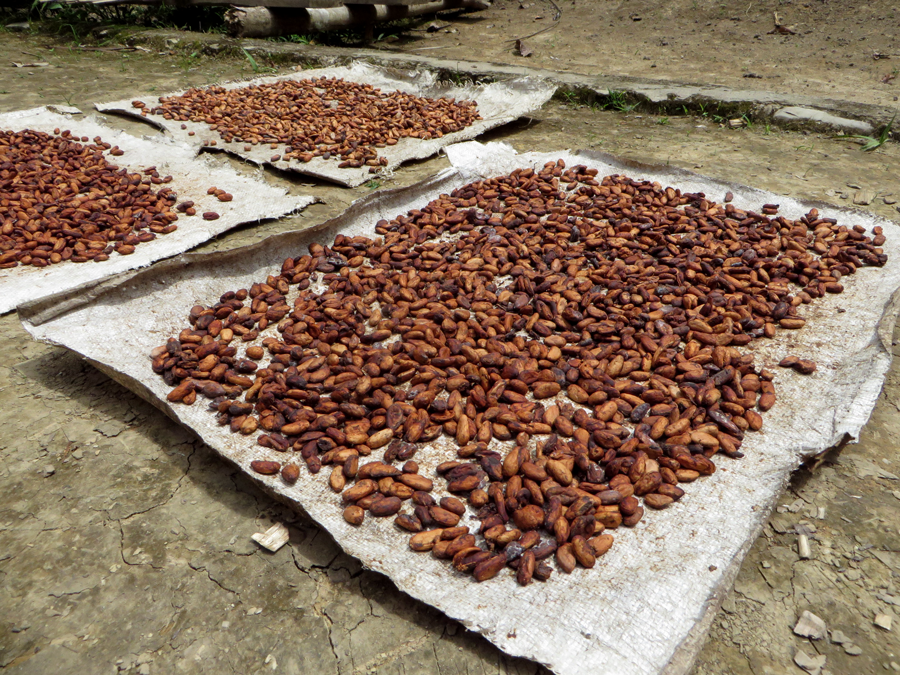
[{"xmin": 151, "ymin": 160, "xmax": 886, "ymax": 584}]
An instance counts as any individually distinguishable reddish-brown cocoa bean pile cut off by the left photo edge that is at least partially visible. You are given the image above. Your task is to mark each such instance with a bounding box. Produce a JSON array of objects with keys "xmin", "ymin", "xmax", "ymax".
[{"xmin": 0, "ymin": 129, "xmax": 178, "ymax": 269}]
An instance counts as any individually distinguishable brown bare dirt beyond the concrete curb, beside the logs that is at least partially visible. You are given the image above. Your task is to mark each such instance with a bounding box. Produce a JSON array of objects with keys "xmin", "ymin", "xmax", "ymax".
[{"xmin": 390, "ymin": 0, "xmax": 900, "ymax": 107}]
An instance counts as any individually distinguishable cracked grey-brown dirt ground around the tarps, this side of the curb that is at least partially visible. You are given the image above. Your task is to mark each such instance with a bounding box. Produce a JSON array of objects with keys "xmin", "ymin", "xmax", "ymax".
[{"xmin": 0, "ymin": 30, "xmax": 900, "ymax": 675}]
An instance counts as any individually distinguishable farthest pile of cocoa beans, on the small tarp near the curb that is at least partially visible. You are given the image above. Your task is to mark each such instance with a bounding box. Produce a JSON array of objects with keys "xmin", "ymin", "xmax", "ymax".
[{"xmin": 132, "ymin": 77, "xmax": 481, "ymax": 170}]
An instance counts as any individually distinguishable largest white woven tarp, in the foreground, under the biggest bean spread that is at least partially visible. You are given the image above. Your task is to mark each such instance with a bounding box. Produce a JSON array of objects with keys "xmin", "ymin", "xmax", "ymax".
[{"xmin": 20, "ymin": 142, "xmax": 900, "ymax": 675}]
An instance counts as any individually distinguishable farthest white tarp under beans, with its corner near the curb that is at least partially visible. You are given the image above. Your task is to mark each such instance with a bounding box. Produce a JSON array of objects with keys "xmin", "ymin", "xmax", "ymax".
[{"xmin": 96, "ymin": 62, "xmax": 556, "ymax": 187}]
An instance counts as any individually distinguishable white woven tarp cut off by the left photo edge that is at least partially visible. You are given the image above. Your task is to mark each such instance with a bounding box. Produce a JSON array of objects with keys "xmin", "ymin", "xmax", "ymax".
[{"xmin": 0, "ymin": 108, "xmax": 316, "ymax": 313}]
